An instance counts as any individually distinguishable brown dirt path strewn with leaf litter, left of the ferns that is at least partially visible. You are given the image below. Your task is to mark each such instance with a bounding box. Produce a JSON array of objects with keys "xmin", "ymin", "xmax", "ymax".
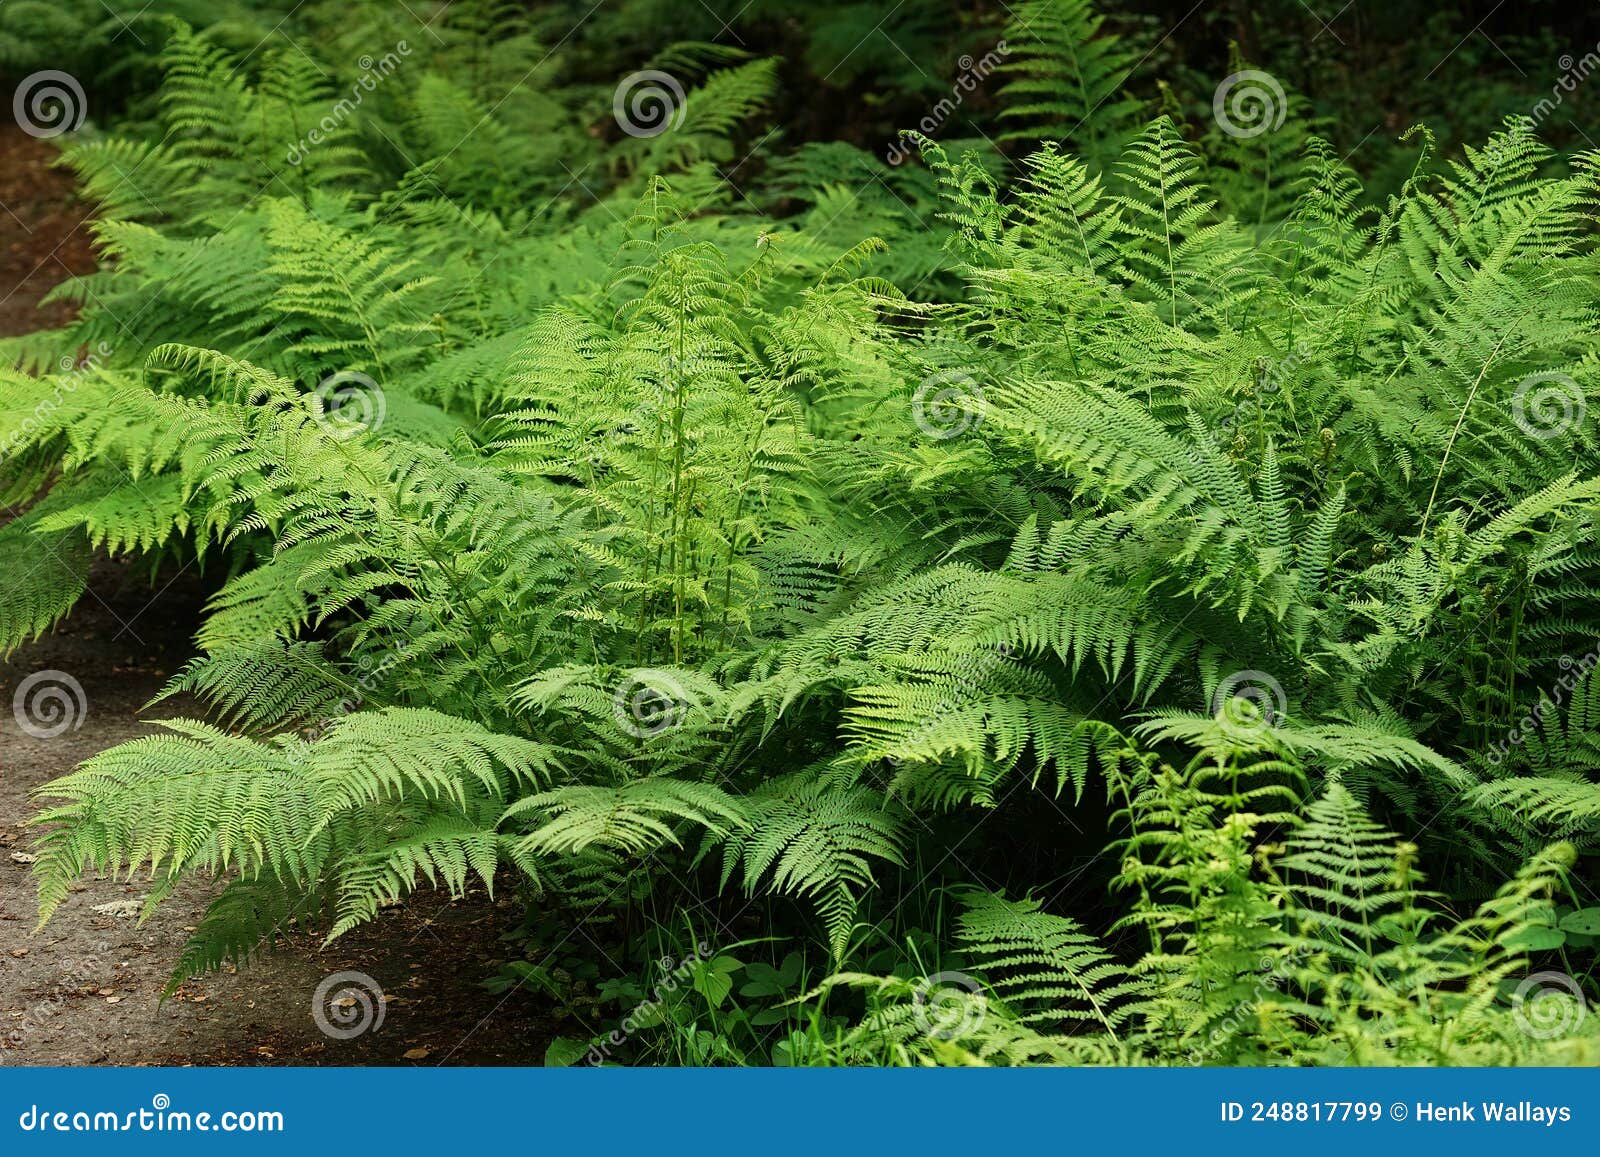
[{"xmin": 0, "ymin": 126, "xmax": 555, "ymax": 1064}]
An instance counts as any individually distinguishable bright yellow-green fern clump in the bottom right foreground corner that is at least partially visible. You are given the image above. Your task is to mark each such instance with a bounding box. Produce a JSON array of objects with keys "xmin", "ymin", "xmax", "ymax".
[{"xmin": 813, "ymin": 752, "xmax": 1600, "ymax": 1066}]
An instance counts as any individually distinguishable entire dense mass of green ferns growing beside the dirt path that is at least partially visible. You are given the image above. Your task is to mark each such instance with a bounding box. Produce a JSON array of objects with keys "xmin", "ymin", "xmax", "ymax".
[{"xmin": 0, "ymin": 2, "xmax": 1600, "ymax": 1064}]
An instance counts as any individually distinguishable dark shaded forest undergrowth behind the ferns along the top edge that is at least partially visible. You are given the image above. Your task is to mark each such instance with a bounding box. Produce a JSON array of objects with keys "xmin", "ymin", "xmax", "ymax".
[{"xmin": 0, "ymin": 0, "xmax": 1600, "ymax": 179}]
